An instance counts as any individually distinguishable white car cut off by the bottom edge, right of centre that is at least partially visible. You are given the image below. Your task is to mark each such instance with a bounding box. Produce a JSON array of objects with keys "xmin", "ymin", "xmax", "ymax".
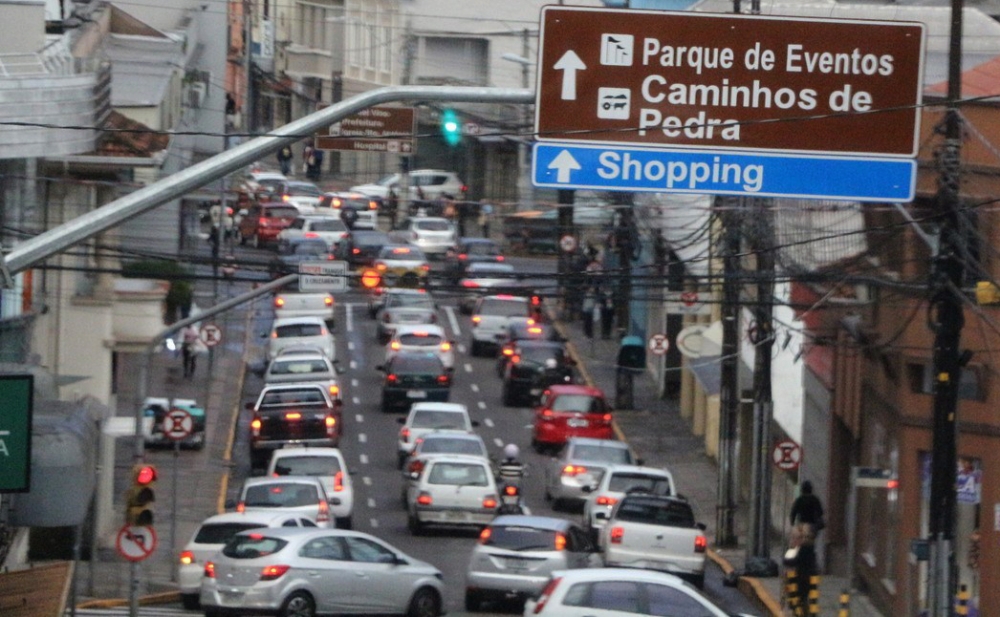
[{"xmin": 524, "ymin": 568, "xmax": 749, "ymax": 617}]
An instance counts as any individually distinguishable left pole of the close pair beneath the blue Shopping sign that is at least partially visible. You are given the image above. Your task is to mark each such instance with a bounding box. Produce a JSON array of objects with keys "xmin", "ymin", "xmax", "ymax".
[{"xmin": 715, "ymin": 197, "xmax": 743, "ymax": 547}]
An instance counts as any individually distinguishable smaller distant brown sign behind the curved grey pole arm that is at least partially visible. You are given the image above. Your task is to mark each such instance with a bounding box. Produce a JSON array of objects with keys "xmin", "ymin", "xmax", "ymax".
[{"xmin": 316, "ymin": 107, "xmax": 415, "ymax": 154}]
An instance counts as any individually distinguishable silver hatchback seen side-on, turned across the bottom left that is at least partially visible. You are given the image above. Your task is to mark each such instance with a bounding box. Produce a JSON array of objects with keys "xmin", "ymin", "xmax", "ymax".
[{"xmin": 201, "ymin": 529, "xmax": 444, "ymax": 617}]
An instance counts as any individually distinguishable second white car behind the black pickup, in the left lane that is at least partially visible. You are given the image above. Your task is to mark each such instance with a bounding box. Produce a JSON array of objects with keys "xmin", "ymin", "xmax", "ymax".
[{"xmin": 236, "ymin": 476, "xmax": 333, "ymax": 527}]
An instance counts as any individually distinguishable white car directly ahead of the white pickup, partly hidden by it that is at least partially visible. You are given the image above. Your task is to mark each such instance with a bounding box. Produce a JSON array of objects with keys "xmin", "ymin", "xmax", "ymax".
[{"xmin": 583, "ymin": 465, "xmax": 677, "ymax": 540}]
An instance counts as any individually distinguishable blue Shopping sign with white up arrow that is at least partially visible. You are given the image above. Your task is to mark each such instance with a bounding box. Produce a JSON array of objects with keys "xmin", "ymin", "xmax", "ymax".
[{"xmin": 532, "ymin": 143, "xmax": 917, "ymax": 202}]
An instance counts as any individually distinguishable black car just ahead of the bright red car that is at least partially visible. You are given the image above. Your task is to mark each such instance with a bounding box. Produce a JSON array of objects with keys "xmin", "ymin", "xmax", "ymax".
[{"xmin": 503, "ymin": 341, "xmax": 576, "ymax": 407}]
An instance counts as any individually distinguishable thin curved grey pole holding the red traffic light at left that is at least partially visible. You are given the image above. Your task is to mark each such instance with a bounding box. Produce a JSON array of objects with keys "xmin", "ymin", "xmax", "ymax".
[{"xmin": 128, "ymin": 274, "xmax": 299, "ymax": 617}]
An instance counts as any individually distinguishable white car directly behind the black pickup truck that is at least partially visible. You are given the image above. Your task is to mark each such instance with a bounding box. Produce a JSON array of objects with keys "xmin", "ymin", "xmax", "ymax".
[{"xmin": 267, "ymin": 448, "xmax": 354, "ymax": 529}]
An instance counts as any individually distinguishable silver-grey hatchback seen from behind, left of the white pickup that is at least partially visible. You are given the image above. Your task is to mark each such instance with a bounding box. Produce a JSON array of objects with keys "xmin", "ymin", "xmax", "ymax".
[{"xmin": 465, "ymin": 515, "xmax": 602, "ymax": 611}]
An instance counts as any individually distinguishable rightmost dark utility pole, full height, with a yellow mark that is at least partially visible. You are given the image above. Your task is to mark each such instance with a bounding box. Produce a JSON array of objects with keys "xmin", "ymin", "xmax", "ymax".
[{"xmin": 924, "ymin": 0, "xmax": 968, "ymax": 617}]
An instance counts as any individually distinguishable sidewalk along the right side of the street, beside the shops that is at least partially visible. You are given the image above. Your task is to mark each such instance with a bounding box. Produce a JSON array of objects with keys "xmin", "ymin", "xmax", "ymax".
[{"xmin": 557, "ymin": 321, "xmax": 883, "ymax": 617}]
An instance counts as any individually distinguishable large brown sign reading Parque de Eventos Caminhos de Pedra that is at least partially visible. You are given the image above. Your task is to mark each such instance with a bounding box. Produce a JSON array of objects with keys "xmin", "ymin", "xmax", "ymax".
[{"xmin": 535, "ymin": 6, "xmax": 924, "ymax": 157}]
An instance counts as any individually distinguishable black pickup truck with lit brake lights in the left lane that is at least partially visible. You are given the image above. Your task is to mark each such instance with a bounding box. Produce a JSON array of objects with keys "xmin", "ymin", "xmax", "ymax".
[{"xmin": 246, "ymin": 384, "xmax": 343, "ymax": 468}]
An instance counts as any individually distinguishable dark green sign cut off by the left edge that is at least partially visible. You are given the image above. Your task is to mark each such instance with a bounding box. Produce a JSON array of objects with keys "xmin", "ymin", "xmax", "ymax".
[{"xmin": 0, "ymin": 375, "xmax": 35, "ymax": 493}]
